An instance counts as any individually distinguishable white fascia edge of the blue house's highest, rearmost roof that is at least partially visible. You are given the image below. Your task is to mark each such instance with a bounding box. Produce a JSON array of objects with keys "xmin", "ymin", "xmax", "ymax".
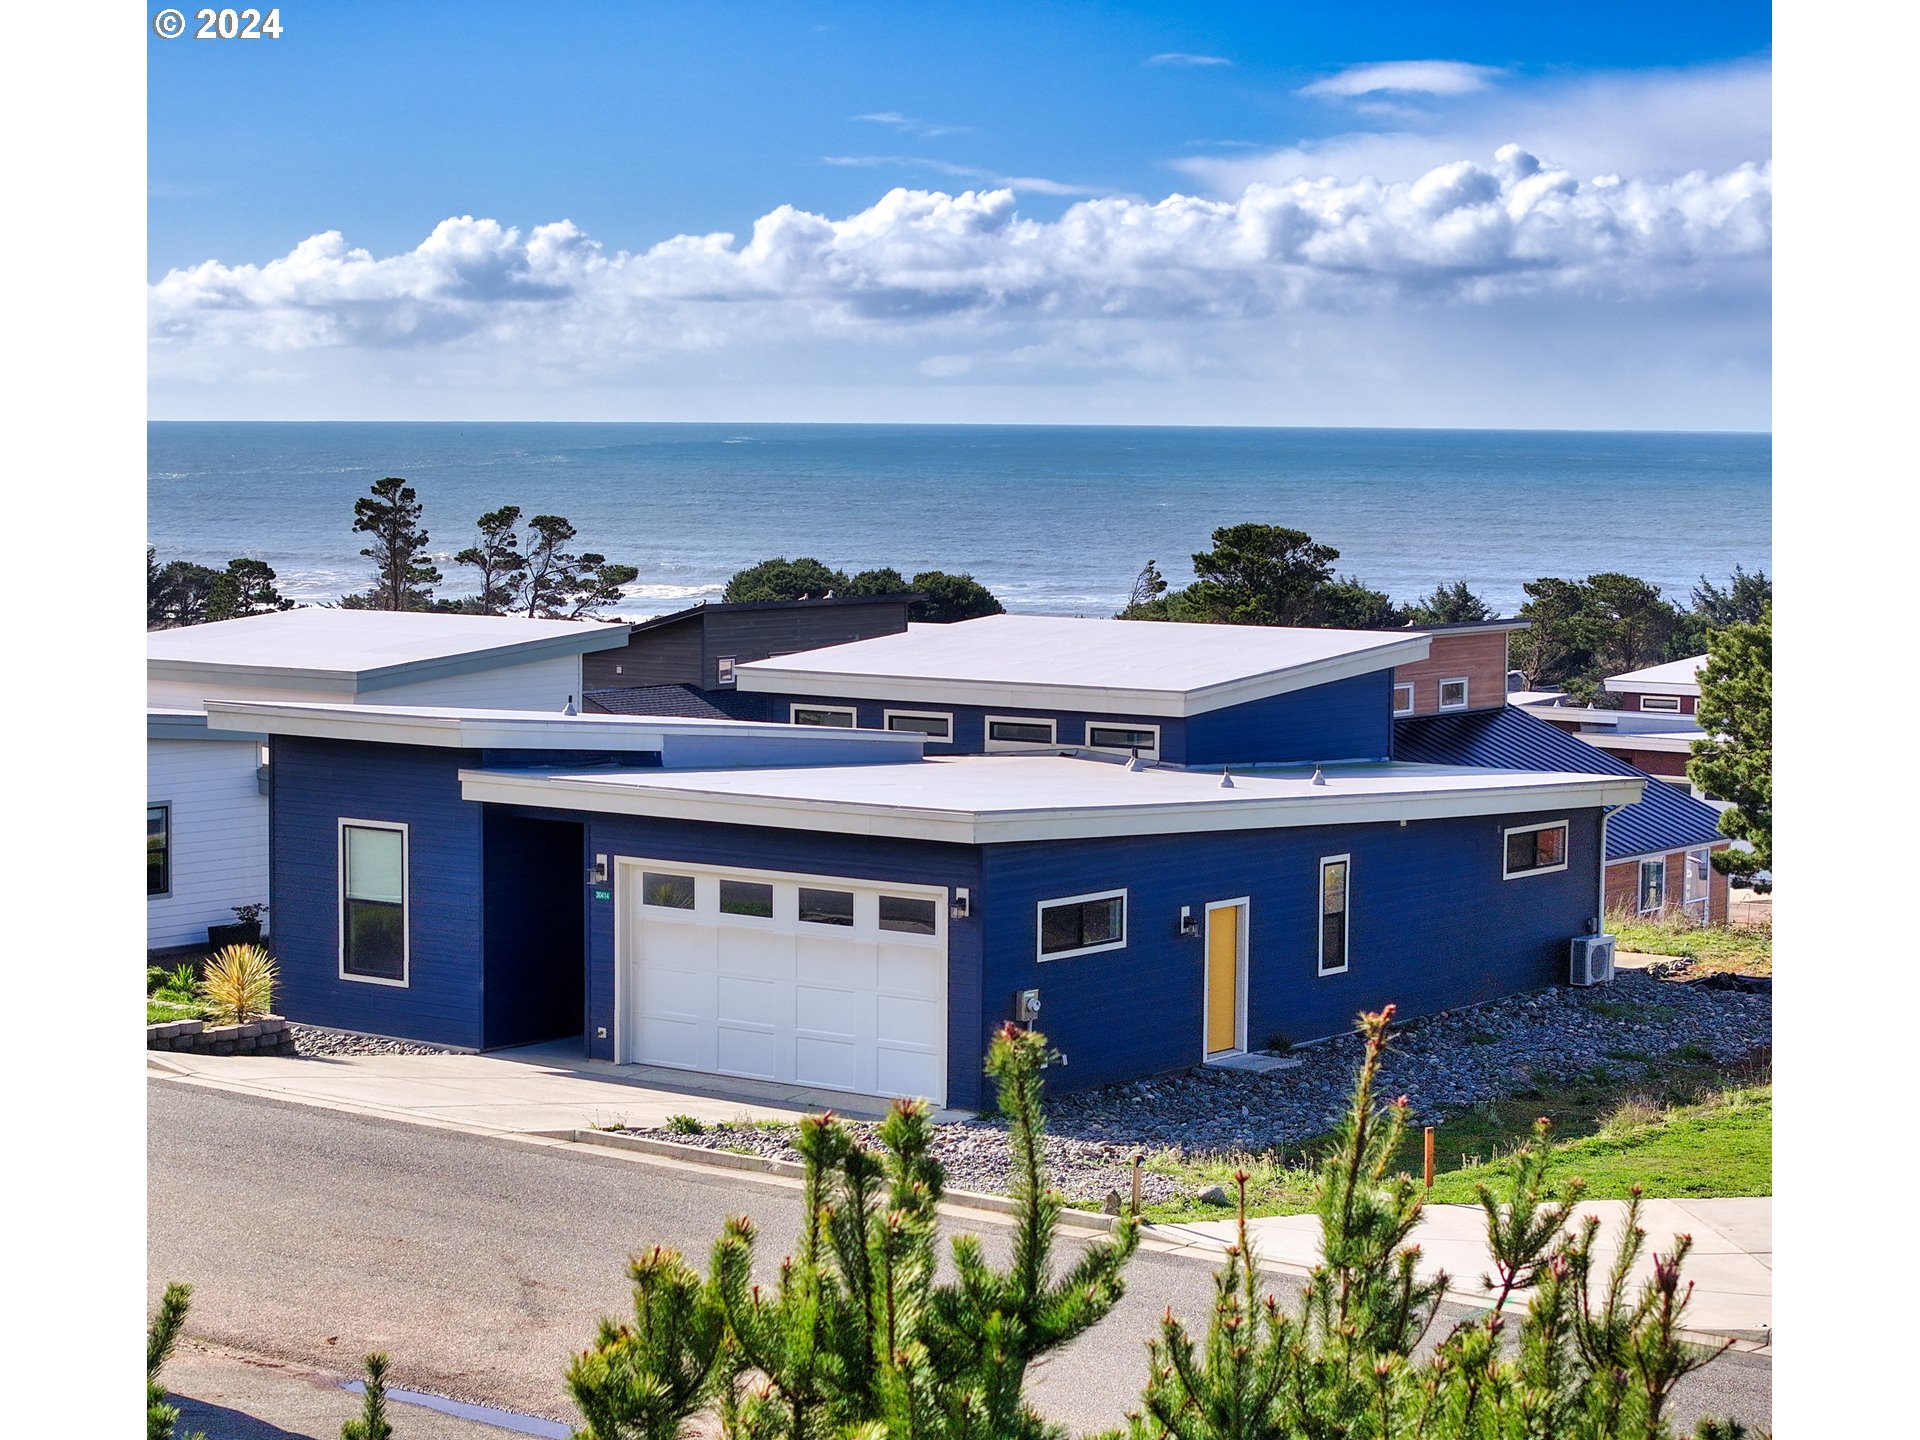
[{"xmin": 735, "ymin": 636, "xmax": 1432, "ymax": 720}]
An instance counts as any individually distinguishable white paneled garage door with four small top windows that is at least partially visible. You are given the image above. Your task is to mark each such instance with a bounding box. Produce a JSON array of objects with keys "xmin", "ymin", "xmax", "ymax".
[{"xmin": 618, "ymin": 860, "xmax": 947, "ymax": 1104}]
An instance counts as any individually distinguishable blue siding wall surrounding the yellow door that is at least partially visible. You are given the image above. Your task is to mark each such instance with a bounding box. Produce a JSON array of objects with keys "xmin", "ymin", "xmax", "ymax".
[{"xmin": 972, "ymin": 810, "xmax": 1599, "ymax": 1089}]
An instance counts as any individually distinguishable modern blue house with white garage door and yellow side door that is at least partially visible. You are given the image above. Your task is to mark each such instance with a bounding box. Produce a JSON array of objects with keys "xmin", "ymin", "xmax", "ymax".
[{"xmin": 207, "ymin": 616, "xmax": 1645, "ymax": 1108}]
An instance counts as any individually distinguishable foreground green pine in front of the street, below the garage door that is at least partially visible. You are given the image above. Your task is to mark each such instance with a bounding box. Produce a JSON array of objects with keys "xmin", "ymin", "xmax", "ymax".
[{"xmin": 568, "ymin": 1025, "xmax": 1139, "ymax": 1440}]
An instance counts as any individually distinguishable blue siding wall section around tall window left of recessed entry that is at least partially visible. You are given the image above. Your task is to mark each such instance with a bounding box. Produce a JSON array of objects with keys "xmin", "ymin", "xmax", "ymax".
[{"xmin": 269, "ymin": 735, "xmax": 486, "ymax": 1048}]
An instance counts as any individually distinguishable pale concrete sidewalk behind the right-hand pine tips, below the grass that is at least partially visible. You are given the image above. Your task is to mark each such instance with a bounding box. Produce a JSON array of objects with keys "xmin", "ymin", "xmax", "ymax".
[{"xmin": 1148, "ymin": 1198, "xmax": 1774, "ymax": 1350}]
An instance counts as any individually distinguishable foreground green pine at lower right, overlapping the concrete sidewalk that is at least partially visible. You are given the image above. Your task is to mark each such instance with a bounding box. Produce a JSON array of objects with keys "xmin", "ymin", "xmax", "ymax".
[{"xmin": 1112, "ymin": 1006, "xmax": 1743, "ymax": 1440}]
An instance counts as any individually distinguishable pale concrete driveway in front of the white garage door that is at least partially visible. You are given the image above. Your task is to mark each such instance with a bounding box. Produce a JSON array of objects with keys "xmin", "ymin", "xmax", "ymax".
[{"xmin": 148, "ymin": 1041, "xmax": 958, "ymax": 1135}]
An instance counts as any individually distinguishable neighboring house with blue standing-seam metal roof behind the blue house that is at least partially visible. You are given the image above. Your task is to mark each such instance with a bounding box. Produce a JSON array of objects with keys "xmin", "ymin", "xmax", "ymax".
[{"xmin": 1394, "ymin": 705, "xmax": 1730, "ymax": 924}]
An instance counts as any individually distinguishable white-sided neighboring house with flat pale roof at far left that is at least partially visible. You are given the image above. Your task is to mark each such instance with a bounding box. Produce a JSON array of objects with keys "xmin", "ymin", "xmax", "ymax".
[{"xmin": 146, "ymin": 609, "xmax": 630, "ymax": 950}]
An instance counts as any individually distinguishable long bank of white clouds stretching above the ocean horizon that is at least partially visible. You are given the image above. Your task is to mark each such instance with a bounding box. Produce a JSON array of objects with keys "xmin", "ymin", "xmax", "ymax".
[{"xmin": 150, "ymin": 123, "xmax": 1772, "ymax": 426}]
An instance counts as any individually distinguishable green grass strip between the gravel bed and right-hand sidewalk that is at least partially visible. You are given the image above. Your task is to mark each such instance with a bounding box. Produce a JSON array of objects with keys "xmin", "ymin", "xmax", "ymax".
[{"xmin": 1144, "ymin": 1050, "xmax": 1774, "ymax": 1221}]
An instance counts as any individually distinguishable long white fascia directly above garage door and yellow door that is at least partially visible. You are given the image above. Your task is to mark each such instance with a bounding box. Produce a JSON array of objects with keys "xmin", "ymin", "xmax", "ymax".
[{"xmin": 461, "ymin": 770, "xmax": 1647, "ymax": 845}]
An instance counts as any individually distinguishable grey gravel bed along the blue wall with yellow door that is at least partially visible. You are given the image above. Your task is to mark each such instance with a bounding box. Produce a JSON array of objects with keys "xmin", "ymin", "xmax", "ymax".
[{"xmin": 632, "ymin": 972, "xmax": 1772, "ymax": 1204}]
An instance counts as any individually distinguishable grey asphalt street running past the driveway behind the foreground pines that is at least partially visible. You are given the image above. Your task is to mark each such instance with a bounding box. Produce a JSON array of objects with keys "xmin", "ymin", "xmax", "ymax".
[{"xmin": 148, "ymin": 1081, "xmax": 1772, "ymax": 1440}]
